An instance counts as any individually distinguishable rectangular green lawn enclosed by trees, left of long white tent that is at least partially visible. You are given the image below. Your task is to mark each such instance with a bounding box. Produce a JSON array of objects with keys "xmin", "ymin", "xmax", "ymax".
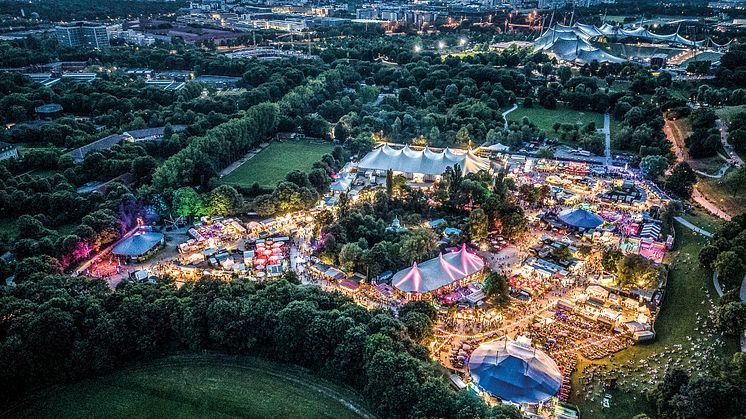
[{"xmin": 223, "ymin": 141, "xmax": 334, "ymax": 187}]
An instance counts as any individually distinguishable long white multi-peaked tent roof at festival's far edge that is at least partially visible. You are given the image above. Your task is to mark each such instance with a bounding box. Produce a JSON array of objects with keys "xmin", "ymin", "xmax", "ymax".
[{"xmin": 358, "ymin": 144, "xmax": 490, "ymax": 176}]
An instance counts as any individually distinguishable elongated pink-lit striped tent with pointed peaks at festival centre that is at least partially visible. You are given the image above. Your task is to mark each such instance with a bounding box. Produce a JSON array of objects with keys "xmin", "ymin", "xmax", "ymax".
[{"xmin": 391, "ymin": 245, "xmax": 484, "ymax": 294}]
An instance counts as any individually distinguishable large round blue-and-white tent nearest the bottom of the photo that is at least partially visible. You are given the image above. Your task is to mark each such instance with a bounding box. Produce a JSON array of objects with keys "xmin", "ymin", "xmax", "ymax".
[{"xmin": 469, "ymin": 339, "xmax": 562, "ymax": 404}]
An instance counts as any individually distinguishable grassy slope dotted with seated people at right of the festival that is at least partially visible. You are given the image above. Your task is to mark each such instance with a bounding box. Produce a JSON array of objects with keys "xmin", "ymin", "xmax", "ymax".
[{"xmin": 573, "ymin": 228, "xmax": 739, "ymax": 419}]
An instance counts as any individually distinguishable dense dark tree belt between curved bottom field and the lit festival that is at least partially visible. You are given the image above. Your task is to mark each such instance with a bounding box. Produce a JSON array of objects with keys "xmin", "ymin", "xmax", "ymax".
[{"xmin": 0, "ymin": 274, "xmax": 520, "ymax": 419}]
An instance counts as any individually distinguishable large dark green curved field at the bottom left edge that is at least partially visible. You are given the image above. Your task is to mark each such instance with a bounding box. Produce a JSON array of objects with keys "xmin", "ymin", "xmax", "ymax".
[{"xmin": 2, "ymin": 355, "xmax": 367, "ymax": 419}]
